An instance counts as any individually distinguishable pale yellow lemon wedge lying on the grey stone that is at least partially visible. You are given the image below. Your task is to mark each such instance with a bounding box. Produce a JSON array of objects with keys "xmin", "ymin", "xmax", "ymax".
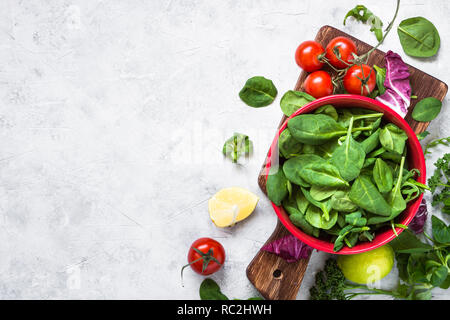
[{"xmin": 208, "ymin": 187, "xmax": 259, "ymax": 228}]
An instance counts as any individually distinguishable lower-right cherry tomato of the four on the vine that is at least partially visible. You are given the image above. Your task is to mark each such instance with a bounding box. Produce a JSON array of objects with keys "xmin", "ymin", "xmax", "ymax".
[{"xmin": 343, "ymin": 64, "xmax": 376, "ymax": 96}]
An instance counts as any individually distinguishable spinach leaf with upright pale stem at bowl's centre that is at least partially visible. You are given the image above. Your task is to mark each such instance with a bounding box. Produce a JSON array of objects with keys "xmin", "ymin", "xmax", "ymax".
[{"xmin": 331, "ymin": 118, "xmax": 366, "ymax": 181}]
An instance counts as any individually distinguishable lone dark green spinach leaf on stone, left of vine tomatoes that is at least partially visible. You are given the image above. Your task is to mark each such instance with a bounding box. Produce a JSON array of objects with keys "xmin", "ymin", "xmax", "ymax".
[{"xmin": 239, "ymin": 76, "xmax": 278, "ymax": 108}]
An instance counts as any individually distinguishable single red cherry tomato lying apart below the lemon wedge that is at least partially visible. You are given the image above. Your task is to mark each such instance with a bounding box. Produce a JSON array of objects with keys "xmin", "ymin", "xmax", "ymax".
[{"xmin": 183, "ymin": 238, "xmax": 225, "ymax": 275}]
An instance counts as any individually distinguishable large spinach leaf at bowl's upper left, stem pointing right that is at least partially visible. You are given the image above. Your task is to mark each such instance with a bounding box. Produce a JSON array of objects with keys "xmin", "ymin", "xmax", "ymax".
[{"xmin": 288, "ymin": 114, "xmax": 347, "ymax": 145}]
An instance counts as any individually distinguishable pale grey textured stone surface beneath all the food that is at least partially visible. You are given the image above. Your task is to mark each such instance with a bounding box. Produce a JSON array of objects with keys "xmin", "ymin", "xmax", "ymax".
[{"xmin": 0, "ymin": 0, "xmax": 450, "ymax": 299}]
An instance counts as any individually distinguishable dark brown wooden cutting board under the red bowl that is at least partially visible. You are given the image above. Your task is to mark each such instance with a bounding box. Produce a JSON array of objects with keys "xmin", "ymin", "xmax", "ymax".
[{"xmin": 247, "ymin": 26, "xmax": 448, "ymax": 300}]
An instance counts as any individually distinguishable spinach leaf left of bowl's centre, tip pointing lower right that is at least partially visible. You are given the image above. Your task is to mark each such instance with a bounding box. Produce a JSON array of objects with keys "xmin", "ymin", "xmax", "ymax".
[{"xmin": 299, "ymin": 159, "xmax": 349, "ymax": 187}]
